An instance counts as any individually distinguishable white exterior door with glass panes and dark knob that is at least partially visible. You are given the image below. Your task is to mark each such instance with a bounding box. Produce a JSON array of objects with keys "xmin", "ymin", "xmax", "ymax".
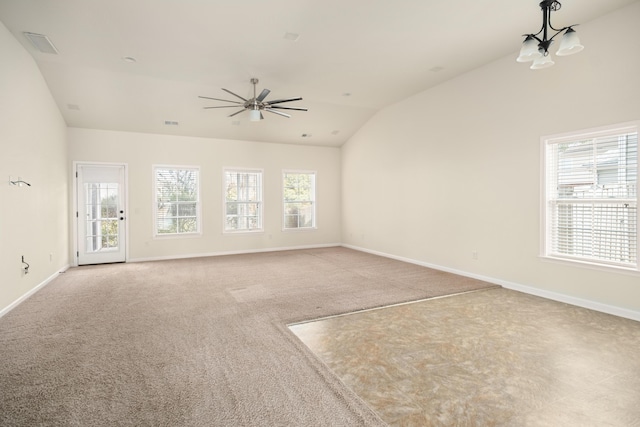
[{"xmin": 76, "ymin": 164, "xmax": 126, "ymax": 265}]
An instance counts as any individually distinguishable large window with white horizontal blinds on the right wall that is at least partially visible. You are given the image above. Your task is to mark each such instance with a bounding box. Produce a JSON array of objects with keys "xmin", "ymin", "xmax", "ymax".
[{"xmin": 543, "ymin": 125, "xmax": 638, "ymax": 270}]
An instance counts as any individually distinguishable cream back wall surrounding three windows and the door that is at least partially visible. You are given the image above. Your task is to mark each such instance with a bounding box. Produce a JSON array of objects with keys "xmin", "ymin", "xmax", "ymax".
[{"xmin": 68, "ymin": 128, "xmax": 341, "ymax": 261}]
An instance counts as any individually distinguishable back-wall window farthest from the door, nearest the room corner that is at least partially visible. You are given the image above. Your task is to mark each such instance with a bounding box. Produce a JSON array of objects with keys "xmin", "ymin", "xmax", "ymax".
[{"xmin": 282, "ymin": 171, "xmax": 316, "ymax": 230}]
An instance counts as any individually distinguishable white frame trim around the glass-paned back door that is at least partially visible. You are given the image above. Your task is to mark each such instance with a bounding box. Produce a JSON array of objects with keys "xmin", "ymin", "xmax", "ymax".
[{"xmin": 69, "ymin": 160, "xmax": 129, "ymax": 267}]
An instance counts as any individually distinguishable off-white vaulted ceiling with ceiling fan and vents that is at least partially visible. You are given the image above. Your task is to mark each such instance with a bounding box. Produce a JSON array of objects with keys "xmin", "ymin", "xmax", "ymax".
[{"xmin": 0, "ymin": 0, "xmax": 637, "ymax": 146}]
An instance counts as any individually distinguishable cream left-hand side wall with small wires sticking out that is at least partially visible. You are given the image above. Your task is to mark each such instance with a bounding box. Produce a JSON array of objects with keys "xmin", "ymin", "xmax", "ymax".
[{"xmin": 0, "ymin": 23, "xmax": 69, "ymax": 314}]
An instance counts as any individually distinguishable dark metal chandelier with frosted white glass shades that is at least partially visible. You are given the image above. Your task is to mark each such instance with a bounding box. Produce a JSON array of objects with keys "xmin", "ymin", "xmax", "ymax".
[{"xmin": 516, "ymin": 0, "xmax": 584, "ymax": 70}]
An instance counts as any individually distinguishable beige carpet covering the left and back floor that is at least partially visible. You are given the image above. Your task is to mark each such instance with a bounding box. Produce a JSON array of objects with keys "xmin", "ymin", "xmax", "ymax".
[{"xmin": 0, "ymin": 247, "xmax": 493, "ymax": 426}]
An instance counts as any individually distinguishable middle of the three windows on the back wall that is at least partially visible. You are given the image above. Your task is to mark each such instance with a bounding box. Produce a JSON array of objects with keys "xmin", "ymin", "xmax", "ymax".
[{"xmin": 224, "ymin": 169, "xmax": 262, "ymax": 232}]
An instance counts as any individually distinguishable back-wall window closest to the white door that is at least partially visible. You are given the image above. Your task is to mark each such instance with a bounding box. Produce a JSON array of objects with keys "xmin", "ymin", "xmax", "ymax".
[{"xmin": 153, "ymin": 166, "xmax": 200, "ymax": 236}]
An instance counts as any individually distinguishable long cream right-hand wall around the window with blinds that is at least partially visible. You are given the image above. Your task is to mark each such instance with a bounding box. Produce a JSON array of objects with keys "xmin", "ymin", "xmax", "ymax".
[{"xmin": 342, "ymin": 2, "xmax": 640, "ymax": 318}]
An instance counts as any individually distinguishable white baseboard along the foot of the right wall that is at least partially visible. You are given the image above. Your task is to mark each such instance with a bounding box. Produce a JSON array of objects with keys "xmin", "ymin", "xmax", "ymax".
[{"xmin": 342, "ymin": 244, "xmax": 640, "ymax": 321}]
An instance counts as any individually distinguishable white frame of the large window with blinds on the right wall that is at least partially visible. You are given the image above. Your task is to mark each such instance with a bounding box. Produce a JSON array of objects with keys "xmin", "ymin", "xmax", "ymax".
[{"xmin": 540, "ymin": 121, "xmax": 640, "ymax": 274}]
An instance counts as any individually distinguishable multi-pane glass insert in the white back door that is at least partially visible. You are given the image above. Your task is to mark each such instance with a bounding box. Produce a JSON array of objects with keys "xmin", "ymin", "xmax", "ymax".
[{"xmin": 84, "ymin": 182, "xmax": 120, "ymax": 252}]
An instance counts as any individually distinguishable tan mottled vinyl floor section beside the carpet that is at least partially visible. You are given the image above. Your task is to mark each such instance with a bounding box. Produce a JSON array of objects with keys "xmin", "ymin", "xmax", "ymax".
[{"xmin": 290, "ymin": 288, "xmax": 640, "ymax": 427}]
